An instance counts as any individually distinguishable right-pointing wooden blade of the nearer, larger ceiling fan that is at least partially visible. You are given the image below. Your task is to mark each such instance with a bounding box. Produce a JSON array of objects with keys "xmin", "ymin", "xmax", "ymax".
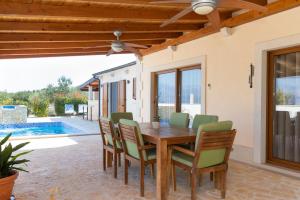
[{"xmin": 218, "ymin": 0, "xmax": 267, "ymax": 11}]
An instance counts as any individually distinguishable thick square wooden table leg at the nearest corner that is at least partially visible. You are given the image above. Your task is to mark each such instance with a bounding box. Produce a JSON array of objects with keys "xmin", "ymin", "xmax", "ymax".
[{"xmin": 156, "ymin": 140, "xmax": 169, "ymax": 200}]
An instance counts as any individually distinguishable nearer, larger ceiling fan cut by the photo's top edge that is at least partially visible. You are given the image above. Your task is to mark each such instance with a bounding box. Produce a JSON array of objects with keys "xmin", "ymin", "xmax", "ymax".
[{"xmin": 150, "ymin": 0, "xmax": 267, "ymax": 29}]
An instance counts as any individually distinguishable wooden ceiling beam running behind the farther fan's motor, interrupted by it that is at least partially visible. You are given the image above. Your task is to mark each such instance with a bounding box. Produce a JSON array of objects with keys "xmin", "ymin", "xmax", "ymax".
[{"xmin": 0, "ymin": 40, "xmax": 165, "ymax": 49}]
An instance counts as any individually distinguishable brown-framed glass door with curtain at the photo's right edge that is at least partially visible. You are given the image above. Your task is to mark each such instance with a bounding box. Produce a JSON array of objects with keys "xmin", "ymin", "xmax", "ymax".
[{"xmin": 268, "ymin": 47, "xmax": 300, "ymax": 169}]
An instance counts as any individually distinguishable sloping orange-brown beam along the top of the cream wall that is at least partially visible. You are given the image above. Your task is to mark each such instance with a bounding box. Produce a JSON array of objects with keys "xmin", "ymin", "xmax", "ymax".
[{"xmin": 141, "ymin": 0, "xmax": 300, "ymax": 56}]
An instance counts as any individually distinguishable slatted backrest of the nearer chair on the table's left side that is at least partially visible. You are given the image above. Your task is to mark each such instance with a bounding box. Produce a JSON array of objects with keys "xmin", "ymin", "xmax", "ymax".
[{"xmin": 118, "ymin": 119, "xmax": 147, "ymax": 160}]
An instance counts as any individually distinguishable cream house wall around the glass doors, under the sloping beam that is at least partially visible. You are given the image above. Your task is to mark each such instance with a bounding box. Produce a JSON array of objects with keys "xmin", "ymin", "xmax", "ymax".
[{"xmin": 141, "ymin": 7, "xmax": 300, "ymax": 165}]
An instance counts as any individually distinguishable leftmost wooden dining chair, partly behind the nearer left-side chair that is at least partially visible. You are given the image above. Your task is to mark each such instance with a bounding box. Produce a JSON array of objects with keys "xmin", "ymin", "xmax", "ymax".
[{"xmin": 99, "ymin": 118, "xmax": 123, "ymax": 178}]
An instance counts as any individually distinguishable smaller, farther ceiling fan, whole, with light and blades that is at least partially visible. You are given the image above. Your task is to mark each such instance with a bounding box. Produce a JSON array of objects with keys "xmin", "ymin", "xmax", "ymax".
[{"xmin": 106, "ymin": 31, "xmax": 148, "ymax": 56}]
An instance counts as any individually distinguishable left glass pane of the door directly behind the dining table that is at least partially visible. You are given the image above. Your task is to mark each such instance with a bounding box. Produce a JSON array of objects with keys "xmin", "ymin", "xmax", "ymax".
[{"xmin": 156, "ymin": 72, "xmax": 176, "ymax": 123}]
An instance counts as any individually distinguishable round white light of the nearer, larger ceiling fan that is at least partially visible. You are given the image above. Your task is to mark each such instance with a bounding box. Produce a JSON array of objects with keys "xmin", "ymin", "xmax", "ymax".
[{"xmin": 192, "ymin": 0, "xmax": 216, "ymax": 15}]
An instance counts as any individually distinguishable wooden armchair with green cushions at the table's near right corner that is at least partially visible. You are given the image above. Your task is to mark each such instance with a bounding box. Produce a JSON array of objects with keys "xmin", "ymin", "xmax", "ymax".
[{"xmin": 172, "ymin": 121, "xmax": 236, "ymax": 200}]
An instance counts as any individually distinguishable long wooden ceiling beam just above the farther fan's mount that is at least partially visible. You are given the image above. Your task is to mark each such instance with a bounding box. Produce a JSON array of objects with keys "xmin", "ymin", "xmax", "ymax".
[{"xmin": 0, "ymin": 21, "xmax": 203, "ymax": 33}]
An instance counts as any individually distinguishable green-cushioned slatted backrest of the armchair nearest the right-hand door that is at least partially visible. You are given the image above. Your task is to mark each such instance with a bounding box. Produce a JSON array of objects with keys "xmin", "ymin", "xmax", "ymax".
[{"xmin": 194, "ymin": 121, "xmax": 236, "ymax": 168}]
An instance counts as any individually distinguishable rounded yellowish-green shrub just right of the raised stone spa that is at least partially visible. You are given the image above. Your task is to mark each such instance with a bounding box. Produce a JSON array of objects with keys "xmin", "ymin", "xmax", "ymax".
[{"xmin": 30, "ymin": 94, "xmax": 49, "ymax": 117}]
